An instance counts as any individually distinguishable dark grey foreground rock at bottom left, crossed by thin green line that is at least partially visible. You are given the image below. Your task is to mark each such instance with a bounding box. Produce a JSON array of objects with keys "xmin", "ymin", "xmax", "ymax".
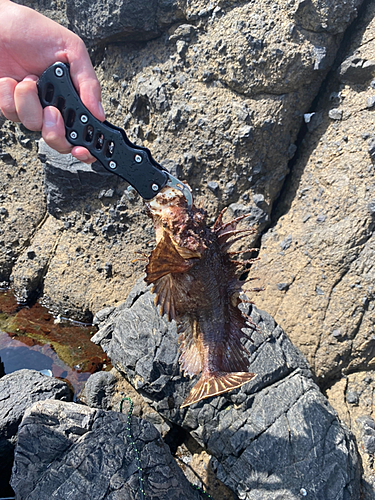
[{"xmin": 11, "ymin": 401, "xmax": 200, "ymax": 500}]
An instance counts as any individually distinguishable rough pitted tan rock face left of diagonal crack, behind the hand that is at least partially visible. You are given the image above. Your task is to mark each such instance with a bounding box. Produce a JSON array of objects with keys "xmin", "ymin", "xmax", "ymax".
[{"xmin": 0, "ymin": 0, "xmax": 361, "ymax": 320}]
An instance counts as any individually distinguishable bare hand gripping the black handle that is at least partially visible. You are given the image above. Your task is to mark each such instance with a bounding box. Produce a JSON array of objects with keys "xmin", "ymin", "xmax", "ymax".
[{"xmin": 0, "ymin": 0, "xmax": 105, "ymax": 163}]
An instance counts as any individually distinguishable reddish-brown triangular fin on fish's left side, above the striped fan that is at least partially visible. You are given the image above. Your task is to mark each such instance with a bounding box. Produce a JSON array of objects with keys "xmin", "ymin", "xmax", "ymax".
[{"xmin": 146, "ymin": 231, "xmax": 192, "ymax": 284}]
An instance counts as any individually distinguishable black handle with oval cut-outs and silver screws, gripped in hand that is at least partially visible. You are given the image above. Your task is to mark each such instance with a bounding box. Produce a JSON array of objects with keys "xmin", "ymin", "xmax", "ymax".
[{"xmin": 37, "ymin": 62, "xmax": 168, "ymax": 200}]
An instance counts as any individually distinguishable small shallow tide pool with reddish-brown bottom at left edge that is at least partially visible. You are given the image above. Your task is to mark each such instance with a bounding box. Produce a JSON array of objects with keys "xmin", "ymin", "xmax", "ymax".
[{"xmin": 0, "ymin": 290, "xmax": 111, "ymax": 397}]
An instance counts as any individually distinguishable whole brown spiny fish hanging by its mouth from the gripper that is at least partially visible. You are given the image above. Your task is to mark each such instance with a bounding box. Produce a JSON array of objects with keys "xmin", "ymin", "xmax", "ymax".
[{"xmin": 146, "ymin": 187, "xmax": 255, "ymax": 408}]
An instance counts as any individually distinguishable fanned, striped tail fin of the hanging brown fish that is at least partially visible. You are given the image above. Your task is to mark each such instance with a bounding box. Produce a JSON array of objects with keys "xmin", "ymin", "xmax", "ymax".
[{"xmin": 181, "ymin": 372, "xmax": 256, "ymax": 408}]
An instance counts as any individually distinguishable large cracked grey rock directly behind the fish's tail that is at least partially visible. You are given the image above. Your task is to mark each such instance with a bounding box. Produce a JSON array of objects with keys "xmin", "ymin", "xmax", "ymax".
[{"xmin": 92, "ymin": 283, "xmax": 360, "ymax": 500}]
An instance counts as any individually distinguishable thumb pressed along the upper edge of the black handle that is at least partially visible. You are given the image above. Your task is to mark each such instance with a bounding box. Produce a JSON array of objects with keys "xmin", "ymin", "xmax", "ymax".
[{"xmin": 66, "ymin": 37, "xmax": 105, "ymax": 121}]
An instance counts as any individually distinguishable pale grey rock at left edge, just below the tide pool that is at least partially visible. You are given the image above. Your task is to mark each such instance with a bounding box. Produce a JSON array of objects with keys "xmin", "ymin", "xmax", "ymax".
[{"xmin": 0, "ymin": 370, "xmax": 72, "ymax": 495}]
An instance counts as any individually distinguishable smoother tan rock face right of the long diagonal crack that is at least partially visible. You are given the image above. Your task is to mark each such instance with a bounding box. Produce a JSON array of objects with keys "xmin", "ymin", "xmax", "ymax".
[{"xmin": 249, "ymin": 3, "xmax": 375, "ymax": 386}]
